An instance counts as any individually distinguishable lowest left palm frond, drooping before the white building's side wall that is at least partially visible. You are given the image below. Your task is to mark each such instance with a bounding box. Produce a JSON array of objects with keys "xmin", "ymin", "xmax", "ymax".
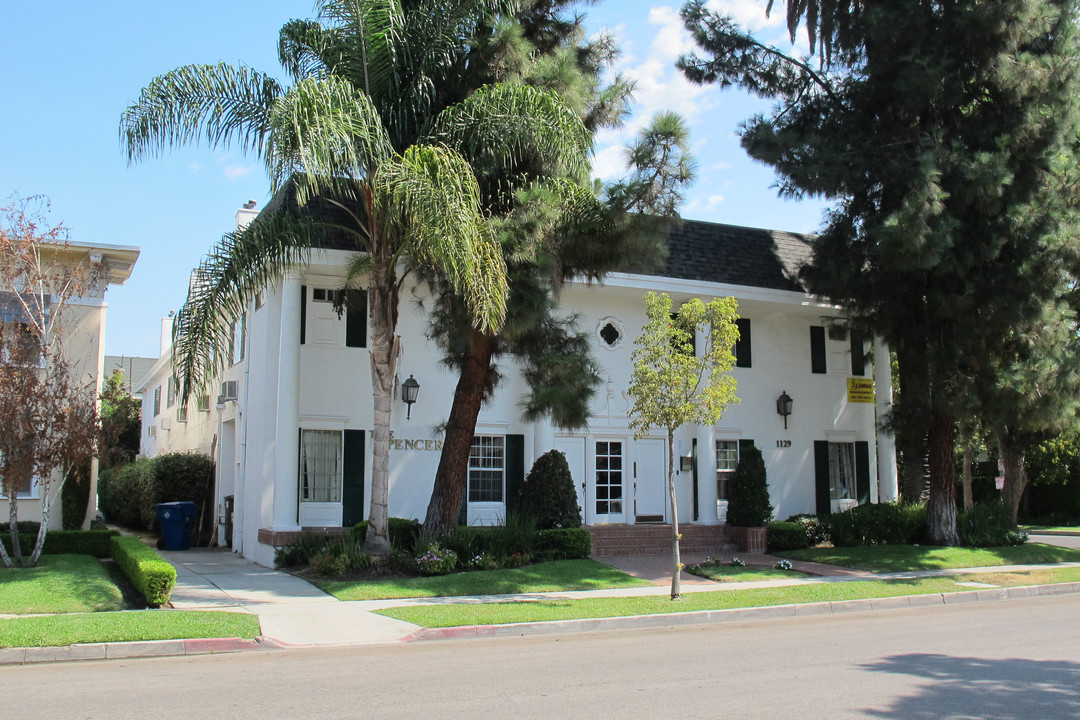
[{"xmin": 173, "ymin": 215, "xmax": 315, "ymax": 398}]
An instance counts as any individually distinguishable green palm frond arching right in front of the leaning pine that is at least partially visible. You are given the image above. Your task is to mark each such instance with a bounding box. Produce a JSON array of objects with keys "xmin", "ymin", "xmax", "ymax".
[{"xmin": 431, "ymin": 83, "xmax": 592, "ymax": 175}]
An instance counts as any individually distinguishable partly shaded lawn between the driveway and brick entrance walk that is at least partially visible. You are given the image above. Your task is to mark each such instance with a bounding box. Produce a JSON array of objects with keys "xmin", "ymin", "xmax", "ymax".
[{"xmin": 315, "ymin": 560, "xmax": 649, "ymax": 600}]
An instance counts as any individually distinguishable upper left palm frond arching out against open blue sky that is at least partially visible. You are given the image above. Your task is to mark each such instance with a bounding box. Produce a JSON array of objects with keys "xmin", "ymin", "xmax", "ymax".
[{"xmin": 120, "ymin": 64, "xmax": 282, "ymax": 162}]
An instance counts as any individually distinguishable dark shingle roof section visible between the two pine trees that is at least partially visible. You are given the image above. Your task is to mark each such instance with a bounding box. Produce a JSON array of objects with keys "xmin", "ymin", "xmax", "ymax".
[{"xmin": 645, "ymin": 220, "xmax": 810, "ymax": 293}]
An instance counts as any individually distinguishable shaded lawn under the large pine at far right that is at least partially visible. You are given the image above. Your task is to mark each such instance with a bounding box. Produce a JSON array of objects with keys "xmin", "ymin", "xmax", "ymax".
[{"xmin": 777, "ymin": 543, "xmax": 1080, "ymax": 572}]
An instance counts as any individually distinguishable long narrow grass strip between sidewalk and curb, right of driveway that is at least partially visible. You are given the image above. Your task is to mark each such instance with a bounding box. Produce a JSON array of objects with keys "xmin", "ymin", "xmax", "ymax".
[{"xmin": 378, "ymin": 568, "xmax": 1080, "ymax": 627}]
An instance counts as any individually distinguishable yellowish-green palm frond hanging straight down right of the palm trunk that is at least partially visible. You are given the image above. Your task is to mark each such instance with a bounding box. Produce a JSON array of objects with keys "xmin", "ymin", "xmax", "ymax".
[{"xmin": 373, "ymin": 146, "xmax": 508, "ymax": 332}]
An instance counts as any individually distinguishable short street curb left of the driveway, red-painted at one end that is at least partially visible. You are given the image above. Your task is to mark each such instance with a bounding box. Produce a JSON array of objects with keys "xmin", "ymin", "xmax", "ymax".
[{"xmin": 0, "ymin": 637, "xmax": 270, "ymax": 665}]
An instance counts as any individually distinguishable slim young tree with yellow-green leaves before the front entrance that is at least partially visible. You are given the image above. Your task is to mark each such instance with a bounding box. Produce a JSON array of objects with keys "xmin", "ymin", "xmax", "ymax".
[{"xmin": 627, "ymin": 293, "xmax": 739, "ymax": 600}]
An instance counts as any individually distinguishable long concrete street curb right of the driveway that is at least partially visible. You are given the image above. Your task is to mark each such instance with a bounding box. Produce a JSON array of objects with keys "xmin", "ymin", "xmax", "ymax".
[{"xmin": 402, "ymin": 583, "xmax": 1080, "ymax": 642}]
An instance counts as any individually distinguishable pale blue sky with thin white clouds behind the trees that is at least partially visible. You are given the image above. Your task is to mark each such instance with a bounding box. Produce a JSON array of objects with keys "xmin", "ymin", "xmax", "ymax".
[{"xmin": 0, "ymin": 0, "xmax": 823, "ymax": 356}]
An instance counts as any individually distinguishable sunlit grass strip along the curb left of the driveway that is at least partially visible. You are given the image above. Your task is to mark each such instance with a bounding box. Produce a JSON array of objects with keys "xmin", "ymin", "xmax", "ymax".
[{"xmin": 0, "ymin": 610, "xmax": 259, "ymax": 648}]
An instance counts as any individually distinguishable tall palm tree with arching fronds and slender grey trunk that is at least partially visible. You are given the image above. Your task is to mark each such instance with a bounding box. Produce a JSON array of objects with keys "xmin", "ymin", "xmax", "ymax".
[{"xmin": 120, "ymin": 0, "xmax": 590, "ymax": 556}]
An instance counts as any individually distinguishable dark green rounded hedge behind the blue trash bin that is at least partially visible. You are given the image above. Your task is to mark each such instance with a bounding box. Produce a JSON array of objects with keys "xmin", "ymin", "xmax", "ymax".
[{"xmin": 97, "ymin": 452, "xmax": 214, "ymax": 530}]
